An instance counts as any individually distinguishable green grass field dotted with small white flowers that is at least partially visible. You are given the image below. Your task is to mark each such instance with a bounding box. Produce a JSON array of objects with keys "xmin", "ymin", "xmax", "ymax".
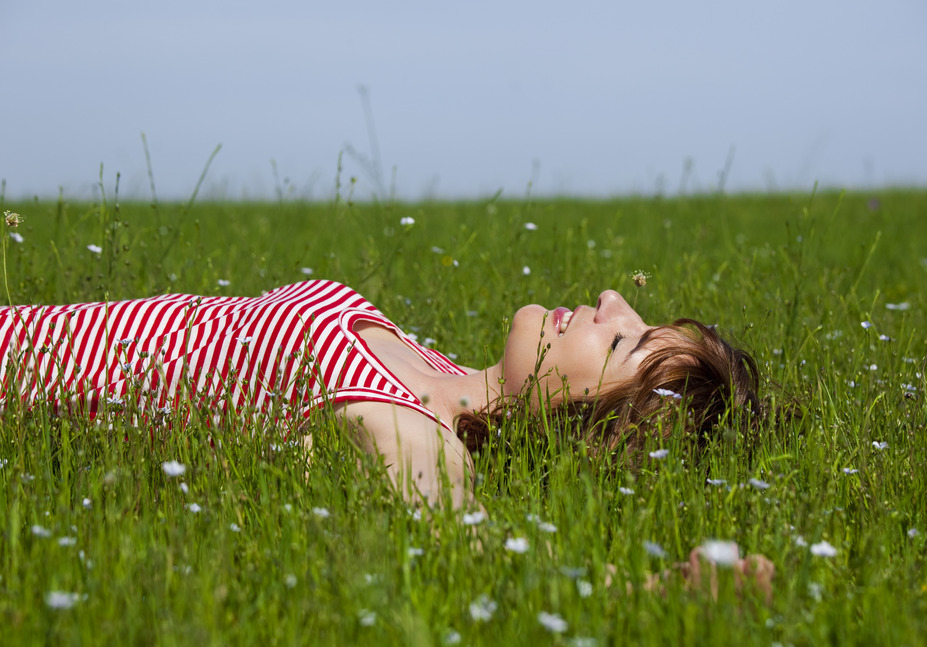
[{"xmin": 0, "ymin": 185, "xmax": 927, "ymax": 645}]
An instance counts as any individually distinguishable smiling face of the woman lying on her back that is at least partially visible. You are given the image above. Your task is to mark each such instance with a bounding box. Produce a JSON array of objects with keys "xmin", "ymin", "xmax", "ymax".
[{"xmin": 503, "ymin": 290, "xmax": 651, "ymax": 402}]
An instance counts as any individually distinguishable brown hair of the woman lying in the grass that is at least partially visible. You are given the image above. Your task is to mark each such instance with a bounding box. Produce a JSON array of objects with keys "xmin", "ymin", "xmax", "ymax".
[{"xmin": 457, "ymin": 319, "xmax": 760, "ymax": 456}]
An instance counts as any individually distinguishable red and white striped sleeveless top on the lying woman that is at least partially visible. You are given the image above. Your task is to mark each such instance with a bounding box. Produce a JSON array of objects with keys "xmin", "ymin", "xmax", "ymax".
[{"xmin": 0, "ymin": 281, "xmax": 465, "ymax": 429}]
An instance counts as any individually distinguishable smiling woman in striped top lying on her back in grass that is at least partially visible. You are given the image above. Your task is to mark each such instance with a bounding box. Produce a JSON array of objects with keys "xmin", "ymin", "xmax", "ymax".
[{"xmin": 0, "ymin": 281, "xmax": 758, "ymax": 505}]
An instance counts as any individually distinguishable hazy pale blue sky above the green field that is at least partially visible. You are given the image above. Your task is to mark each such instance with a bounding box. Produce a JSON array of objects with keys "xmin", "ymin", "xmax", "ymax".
[{"xmin": 0, "ymin": 0, "xmax": 927, "ymax": 200}]
